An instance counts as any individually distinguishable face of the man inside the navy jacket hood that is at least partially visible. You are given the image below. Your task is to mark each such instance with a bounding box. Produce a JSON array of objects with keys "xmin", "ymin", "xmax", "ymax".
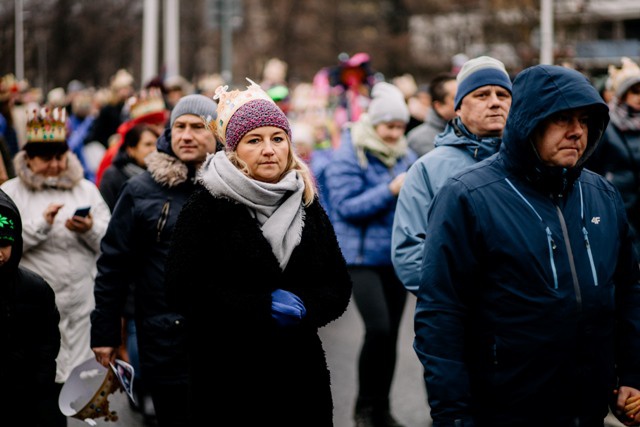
[{"xmin": 534, "ymin": 108, "xmax": 589, "ymax": 168}]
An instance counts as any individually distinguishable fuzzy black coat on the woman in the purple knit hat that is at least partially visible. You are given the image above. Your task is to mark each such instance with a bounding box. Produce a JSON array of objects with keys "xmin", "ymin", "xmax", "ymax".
[{"xmin": 166, "ymin": 189, "xmax": 351, "ymax": 426}]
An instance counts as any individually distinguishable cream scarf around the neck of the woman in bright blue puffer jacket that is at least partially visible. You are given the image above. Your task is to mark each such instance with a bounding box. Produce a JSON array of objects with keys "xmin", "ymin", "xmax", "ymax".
[{"xmin": 351, "ymin": 113, "xmax": 408, "ymax": 168}]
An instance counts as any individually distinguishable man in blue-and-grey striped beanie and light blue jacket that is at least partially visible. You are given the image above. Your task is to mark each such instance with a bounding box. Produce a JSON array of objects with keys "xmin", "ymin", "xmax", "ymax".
[{"xmin": 391, "ymin": 56, "xmax": 511, "ymax": 293}]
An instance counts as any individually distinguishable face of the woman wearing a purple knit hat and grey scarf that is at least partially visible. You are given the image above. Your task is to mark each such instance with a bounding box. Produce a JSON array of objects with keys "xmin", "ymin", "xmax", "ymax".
[{"xmin": 236, "ymin": 126, "xmax": 291, "ymax": 183}]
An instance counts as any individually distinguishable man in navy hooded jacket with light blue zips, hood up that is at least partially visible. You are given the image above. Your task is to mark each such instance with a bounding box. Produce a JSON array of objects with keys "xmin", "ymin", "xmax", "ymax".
[{"xmin": 414, "ymin": 65, "xmax": 640, "ymax": 427}]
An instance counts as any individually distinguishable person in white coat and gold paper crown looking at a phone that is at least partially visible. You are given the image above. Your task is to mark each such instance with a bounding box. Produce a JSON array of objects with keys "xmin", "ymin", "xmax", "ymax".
[{"xmin": 0, "ymin": 108, "xmax": 110, "ymax": 425}]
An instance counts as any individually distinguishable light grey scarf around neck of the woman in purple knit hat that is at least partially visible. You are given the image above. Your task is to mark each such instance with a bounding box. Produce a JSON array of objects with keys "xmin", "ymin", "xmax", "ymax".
[{"xmin": 199, "ymin": 151, "xmax": 304, "ymax": 270}]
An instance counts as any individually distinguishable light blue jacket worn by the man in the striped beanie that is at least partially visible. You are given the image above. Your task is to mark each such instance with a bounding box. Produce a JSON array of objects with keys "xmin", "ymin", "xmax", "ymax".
[{"xmin": 391, "ymin": 118, "xmax": 500, "ymax": 293}]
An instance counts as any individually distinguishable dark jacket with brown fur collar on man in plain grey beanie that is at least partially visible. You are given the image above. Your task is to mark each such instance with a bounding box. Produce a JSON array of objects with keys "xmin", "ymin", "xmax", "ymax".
[{"xmin": 91, "ymin": 153, "xmax": 195, "ymax": 386}]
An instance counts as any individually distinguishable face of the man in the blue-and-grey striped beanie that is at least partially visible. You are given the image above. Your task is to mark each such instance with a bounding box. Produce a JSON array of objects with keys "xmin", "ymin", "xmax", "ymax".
[{"xmin": 456, "ymin": 85, "xmax": 511, "ymax": 137}]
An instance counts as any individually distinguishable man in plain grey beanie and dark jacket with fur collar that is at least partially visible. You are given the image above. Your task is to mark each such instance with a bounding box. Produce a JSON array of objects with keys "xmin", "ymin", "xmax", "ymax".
[{"xmin": 91, "ymin": 95, "xmax": 216, "ymax": 427}]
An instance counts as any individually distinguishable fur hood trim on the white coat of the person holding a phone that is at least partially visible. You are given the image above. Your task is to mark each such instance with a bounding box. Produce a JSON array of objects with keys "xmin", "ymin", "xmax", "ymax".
[{"xmin": 13, "ymin": 150, "xmax": 84, "ymax": 191}]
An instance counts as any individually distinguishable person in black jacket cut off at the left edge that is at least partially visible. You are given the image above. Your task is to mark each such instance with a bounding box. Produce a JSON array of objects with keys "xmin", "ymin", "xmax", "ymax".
[{"xmin": 0, "ymin": 190, "xmax": 60, "ymax": 427}]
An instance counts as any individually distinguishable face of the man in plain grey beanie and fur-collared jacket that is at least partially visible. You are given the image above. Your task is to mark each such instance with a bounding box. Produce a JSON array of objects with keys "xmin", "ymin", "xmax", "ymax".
[{"xmin": 171, "ymin": 114, "xmax": 216, "ymax": 165}]
